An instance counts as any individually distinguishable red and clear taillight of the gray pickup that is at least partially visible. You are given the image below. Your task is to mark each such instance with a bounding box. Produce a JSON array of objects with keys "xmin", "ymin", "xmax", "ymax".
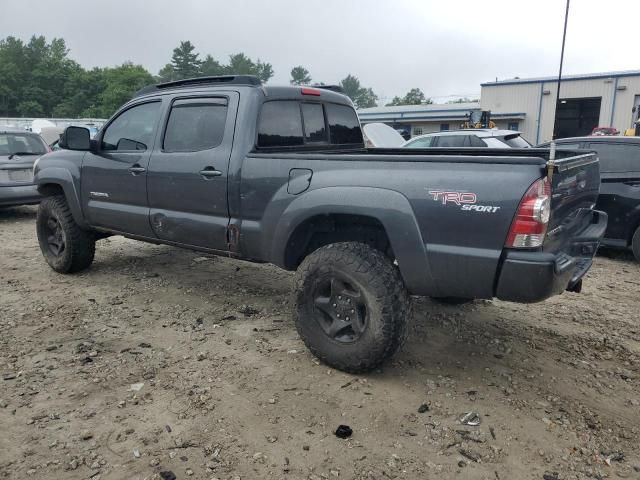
[{"xmin": 505, "ymin": 177, "xmax": 551, "ymax": 248}]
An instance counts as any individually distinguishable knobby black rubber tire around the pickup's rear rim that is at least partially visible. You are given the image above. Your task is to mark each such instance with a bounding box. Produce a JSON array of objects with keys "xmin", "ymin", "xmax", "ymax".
[{"xmin": 295, "ymin": 242, "xmax": 411, "ymax": 373}]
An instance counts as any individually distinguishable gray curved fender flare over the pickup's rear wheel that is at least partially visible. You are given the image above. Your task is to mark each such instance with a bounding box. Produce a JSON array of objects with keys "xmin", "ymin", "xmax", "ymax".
[{"xmin": 267, "ymin": 186, "xmax": 435, "ymax": 295}]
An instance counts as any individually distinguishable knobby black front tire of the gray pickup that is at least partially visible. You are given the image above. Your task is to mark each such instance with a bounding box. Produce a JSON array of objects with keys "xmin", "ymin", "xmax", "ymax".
[{"xmin": 36, "ymin": 195, "xmax": 96, "ymax": 273}]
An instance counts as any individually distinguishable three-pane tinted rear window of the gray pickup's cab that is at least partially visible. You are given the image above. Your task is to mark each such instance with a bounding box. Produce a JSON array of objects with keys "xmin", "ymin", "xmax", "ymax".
[{"xmin": 258, "ymin": 100, "xmax": 363, "ymax": 147}]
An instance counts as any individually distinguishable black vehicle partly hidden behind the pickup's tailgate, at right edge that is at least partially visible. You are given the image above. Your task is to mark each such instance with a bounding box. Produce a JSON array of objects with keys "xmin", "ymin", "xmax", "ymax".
[{"xmin": 545, "ymin": 135, "xmax": 640, "ymax": 262}]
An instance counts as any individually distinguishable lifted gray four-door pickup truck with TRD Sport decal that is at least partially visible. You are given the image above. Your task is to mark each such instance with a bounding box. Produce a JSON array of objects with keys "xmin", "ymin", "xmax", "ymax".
[{"xmin": 34, "ymin": 76, "xmax": 607, "ymax": 372}]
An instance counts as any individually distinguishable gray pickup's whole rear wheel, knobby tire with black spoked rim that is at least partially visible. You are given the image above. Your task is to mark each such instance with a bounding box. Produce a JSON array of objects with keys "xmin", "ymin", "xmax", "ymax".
[{"xmin": 296, "ymin": 242, "xmax": 410, "ymax": 373}]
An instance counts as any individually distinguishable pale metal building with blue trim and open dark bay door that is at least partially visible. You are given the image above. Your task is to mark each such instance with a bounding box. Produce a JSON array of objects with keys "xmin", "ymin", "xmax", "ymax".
[{"xmin": 358, "ymin": 70, "xmax": 640, "ymax": 144}]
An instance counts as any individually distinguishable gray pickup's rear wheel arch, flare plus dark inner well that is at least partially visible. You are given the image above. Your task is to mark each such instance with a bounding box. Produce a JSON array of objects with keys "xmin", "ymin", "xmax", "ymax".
[{"xmin": 270, "ymin": 186, "xmax": 434, "ymax": 295}]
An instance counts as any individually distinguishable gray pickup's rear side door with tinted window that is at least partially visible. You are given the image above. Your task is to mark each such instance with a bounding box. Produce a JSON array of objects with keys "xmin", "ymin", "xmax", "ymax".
[{"xmin": 147, "ymin": 92, "xmax": 239, "ymax": 251}]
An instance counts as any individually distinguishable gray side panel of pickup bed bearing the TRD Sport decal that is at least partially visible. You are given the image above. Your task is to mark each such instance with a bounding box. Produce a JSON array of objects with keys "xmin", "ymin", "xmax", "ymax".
[{"xmin": 232, "ymin": 154, "xmax": 544, "ymax": 298}]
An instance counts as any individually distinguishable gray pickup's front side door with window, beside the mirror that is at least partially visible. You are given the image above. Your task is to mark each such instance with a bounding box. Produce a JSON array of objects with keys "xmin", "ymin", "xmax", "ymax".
[{"xmin": 81, "ymin": 100, "xmax": 162, "ymax": 237}]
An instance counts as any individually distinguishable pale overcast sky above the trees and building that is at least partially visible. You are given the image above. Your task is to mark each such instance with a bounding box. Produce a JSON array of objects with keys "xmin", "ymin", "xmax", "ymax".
[{"xmin": 0, "ymin": 0, "xmax": 640, "ymax": 102}]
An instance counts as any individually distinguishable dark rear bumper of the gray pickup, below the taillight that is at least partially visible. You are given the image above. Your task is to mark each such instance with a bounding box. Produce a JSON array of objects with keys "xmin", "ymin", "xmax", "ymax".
[{"xmin": 496, "ymin": 211, "xmax": 607, "ymax": 303}]
